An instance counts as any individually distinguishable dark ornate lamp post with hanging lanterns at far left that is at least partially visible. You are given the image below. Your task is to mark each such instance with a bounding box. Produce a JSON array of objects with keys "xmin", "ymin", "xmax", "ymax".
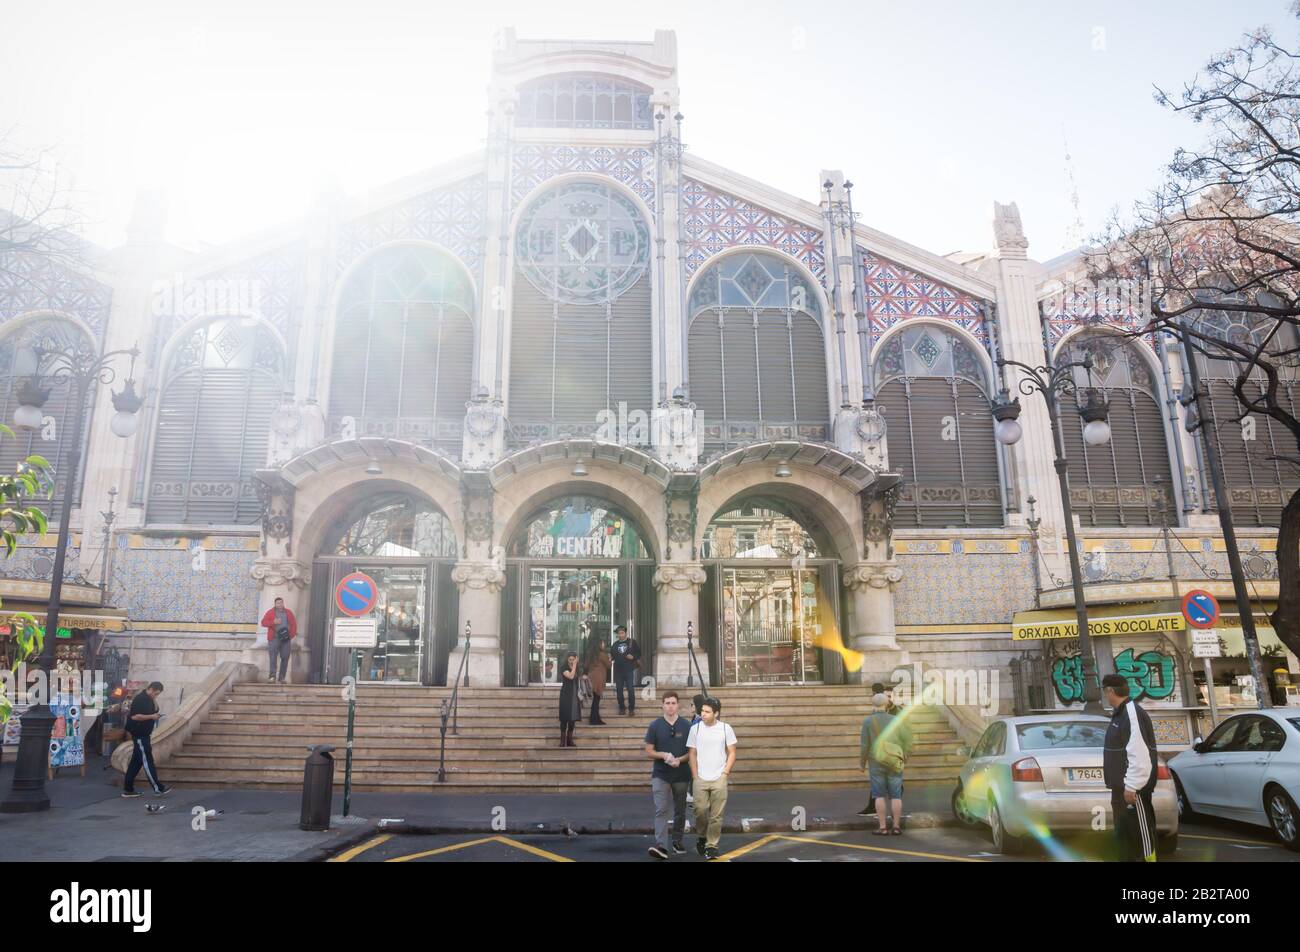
[{"xmin": 0, "ymin": 338, "xmax": 144, "ymax": 813}]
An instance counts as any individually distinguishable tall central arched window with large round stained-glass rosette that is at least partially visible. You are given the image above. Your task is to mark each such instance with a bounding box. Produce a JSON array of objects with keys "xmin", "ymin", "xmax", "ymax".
[{"xmin": 510, "ymin": 182, "xmax": 654, "ymax": 441}]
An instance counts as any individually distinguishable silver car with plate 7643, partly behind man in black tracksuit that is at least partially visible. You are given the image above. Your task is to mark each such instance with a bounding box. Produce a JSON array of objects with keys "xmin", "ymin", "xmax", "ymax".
[{"xmin": 952, "ymin": 713, "xmax": 1178, "ymax": 854}]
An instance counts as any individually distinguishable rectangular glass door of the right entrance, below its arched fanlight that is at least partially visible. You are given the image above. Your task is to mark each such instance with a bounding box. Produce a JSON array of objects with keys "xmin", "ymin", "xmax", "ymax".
[{"xmin": 722, "ymin": 567, "xmax": 829, "ymax": 684}]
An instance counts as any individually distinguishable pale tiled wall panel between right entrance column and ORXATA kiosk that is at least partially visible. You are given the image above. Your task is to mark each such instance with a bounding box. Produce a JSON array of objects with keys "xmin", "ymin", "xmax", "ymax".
[{"xmin": 894, "ymin": 553, "xmax": 1034, "ymax": 626}]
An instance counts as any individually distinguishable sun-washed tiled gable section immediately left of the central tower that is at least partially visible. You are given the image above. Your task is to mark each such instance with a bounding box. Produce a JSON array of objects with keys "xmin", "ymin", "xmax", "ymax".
[{"xmin": 338, "ymin": 174, "xmax": 486, "ymax": 276}]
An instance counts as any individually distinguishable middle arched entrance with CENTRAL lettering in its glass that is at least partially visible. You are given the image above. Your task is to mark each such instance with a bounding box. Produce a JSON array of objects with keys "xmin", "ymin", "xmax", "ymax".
[{"xmin": 502, "ymin": 493, "xmax": 657, "ymax": 685}]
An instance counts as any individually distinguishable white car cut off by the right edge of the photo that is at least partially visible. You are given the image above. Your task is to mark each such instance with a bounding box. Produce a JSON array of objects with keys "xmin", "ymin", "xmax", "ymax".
[{"xmin": 1169, "ymin": 707, "xmax": 1300, "ymax": 849}]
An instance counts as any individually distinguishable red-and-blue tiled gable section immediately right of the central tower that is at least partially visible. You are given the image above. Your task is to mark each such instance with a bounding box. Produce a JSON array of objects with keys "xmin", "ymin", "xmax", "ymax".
[{"xmin": 681, "ymin": 178, "xmax": 826, "ymax": 287}]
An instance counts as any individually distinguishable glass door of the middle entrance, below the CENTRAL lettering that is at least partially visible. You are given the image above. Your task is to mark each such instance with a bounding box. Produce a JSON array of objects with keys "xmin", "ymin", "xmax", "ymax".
[{"xmin": 528, "ymin": 567, "xmax": 619, "ymax": 684}]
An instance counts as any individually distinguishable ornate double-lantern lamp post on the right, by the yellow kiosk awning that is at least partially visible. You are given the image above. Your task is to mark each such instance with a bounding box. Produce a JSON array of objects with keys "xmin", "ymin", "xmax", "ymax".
[{"xmin": 992, "ymin": 354, "xmax": 1110, "ymax": 714}]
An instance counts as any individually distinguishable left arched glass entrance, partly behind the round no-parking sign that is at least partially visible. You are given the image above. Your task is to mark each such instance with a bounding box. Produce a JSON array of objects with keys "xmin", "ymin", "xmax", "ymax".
[{"xmin": 308, "ymin": 489, "xmax": 458, "ymax": 684}]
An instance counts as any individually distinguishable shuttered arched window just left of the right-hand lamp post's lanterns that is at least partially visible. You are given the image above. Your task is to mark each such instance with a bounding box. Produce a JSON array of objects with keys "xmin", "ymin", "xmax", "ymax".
[{"xmin": 875, "ymin": 323, "xmax": 1002, "ymax": 528}]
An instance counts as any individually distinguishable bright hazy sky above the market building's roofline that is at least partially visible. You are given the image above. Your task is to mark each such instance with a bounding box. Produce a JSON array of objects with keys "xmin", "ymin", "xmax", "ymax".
[{"xmin": 0, "ymin": 0, "xmax": 1297, "ymax": 260}]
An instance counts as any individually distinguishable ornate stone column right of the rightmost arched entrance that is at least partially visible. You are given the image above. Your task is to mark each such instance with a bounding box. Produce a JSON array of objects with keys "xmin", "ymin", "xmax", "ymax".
[{"xmin": 844, "ymin": 480, "xmax": 907, "ymax": 684}]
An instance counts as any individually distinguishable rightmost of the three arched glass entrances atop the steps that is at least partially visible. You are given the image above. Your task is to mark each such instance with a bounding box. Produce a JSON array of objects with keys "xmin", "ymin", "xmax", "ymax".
[{"xmin": 699, "ymin": 493, "xmax": 842, "ymax": 684}]
